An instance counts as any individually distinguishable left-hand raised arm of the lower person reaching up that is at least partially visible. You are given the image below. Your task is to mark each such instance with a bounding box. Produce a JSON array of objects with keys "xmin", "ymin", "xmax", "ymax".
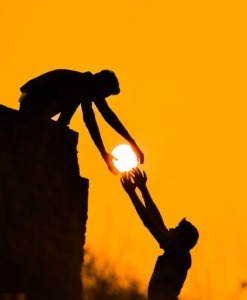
[{"xmin": 121, "ymin": 173, "xmax": 169, "ymax": 245}]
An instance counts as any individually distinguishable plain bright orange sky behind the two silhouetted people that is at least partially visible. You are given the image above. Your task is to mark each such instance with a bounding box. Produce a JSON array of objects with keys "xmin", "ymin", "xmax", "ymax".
[{"xmin": 0, "ymin": 0, "xmax": 247, "ymax": 300}]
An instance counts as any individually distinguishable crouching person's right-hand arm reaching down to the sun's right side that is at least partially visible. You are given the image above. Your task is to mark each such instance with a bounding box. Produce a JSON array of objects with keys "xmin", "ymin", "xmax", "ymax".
[{"xmin": 95, "ymin": 98, "xmax": 144, "ymax": 164}]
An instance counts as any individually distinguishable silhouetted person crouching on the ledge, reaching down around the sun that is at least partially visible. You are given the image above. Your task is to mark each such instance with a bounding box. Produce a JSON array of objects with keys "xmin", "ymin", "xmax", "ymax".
[{"xmin": 19, "ymin": 69, "xmax": 144, "ymax": 174}]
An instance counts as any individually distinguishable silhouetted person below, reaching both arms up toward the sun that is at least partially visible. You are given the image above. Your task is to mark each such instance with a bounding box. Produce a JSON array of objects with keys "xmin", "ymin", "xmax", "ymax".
[{"xmin": 121, "ymin": 168, "xmax": 199, "ymax": 300}]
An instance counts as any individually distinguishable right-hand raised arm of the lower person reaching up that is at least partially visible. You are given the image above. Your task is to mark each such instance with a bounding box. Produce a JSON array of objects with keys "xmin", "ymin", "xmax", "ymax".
[{"xmin": 131, "ymin": 168, "xmax": 168, "ymax": 231}]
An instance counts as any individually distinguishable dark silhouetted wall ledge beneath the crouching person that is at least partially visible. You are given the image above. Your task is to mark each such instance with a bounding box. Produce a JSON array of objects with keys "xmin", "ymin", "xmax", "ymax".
[{"xmin": 0, "ymin": 106, "xmax": 88, "ymax": 300}]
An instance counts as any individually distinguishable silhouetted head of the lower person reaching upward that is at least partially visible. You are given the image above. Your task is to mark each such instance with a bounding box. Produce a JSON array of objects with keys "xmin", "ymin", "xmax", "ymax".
[{"xmin": 175, "ymin": 218, "xmax": 199, "ymax": 250}]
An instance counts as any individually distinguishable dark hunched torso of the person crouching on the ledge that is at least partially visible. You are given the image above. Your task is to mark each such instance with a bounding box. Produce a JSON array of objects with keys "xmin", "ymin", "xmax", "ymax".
[{"xmin": 20, "ymin": 69, "xmax": 100, "ymax": 125}]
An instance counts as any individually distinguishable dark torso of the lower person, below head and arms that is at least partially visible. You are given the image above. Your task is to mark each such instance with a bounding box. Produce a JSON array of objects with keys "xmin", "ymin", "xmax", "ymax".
[{"xmin": 148, "ymin": 247, "xmax": 191, "ymax": 300}]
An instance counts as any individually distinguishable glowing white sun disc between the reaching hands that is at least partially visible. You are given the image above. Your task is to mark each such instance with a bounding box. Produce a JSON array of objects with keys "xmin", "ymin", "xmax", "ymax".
[{"xmin": 112, "ymin": 144, "xmax": 138, "ymax": 172}]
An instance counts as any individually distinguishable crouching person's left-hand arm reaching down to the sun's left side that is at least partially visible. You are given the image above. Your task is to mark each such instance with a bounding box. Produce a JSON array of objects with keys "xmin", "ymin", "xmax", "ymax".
[{"xmin": 81, "ymin": 101, "xmax": 118, "ymax": 175}]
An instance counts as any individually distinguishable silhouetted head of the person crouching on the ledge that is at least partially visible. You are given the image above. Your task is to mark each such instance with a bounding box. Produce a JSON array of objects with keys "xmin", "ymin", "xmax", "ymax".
[{"xmin": 94, "ymin": 70, "xmax": 120, "ymax": 97}]
